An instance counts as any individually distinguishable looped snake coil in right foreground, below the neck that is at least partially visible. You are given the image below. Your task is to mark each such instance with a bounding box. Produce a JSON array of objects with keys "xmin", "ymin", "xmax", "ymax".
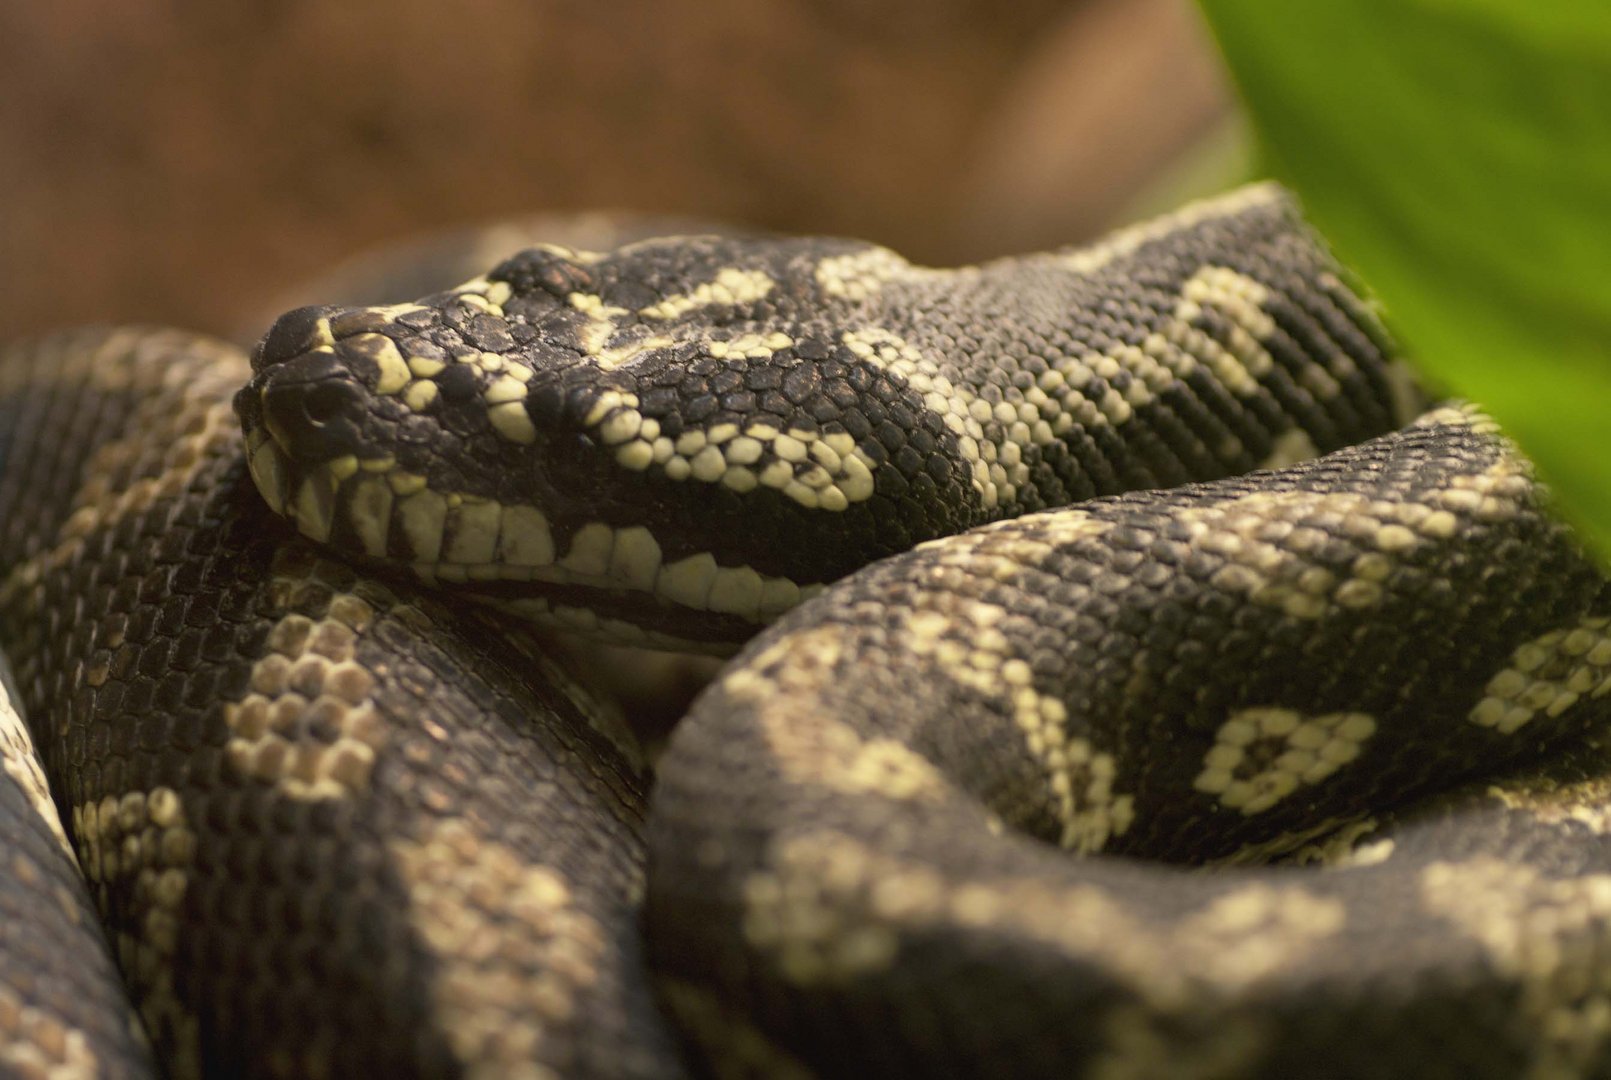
[{"xmin": 648, "ymin": 411, "xmax": 1611, "ymax": 1077}]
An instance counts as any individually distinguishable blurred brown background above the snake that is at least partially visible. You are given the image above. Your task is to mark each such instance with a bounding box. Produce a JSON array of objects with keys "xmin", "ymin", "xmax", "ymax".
[{"xmin": 0, "ymin": 0, "xmax": 1236, "ymax": 337}]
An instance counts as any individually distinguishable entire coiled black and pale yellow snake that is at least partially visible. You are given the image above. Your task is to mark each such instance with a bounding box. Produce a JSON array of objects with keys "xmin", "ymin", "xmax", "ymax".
[{"xmin": 0, "ymin": 185, "xmax": 1611, "ymax": 1078}]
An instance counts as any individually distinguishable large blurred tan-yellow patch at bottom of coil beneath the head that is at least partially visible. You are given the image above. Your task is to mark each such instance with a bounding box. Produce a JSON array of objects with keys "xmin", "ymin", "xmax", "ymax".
[{"xmin": 390, "ymin": 819, "xmax": 609, "ymax": 1080}]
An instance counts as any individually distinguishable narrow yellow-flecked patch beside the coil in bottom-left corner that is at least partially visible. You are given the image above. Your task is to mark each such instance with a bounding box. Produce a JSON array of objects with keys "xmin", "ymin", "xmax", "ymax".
[{"xmin": 72, "ymin": 788, "xmax": 201, "ymax": 1077}]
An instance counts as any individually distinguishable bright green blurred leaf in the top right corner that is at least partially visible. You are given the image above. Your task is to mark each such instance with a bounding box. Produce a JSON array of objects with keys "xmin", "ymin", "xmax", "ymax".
[{"xmin": 1200, "ymin": 0, "xmax": 1611, "ymax": 556}]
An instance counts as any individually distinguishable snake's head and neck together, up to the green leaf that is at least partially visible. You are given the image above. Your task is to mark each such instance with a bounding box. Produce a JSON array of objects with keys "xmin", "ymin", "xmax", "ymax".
[{"xmin": 237, "ymin": 187, "xmax": 1408, "ymax": 643}]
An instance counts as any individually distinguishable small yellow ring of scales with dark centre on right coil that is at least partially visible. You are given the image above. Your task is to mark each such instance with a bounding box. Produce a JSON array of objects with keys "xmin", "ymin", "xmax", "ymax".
[{"xmin": 1192, "ymin": 708, "xmax": 1376, "ymax": 816}]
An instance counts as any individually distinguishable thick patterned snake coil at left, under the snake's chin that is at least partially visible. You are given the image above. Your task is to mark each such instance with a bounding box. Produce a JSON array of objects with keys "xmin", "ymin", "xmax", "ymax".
[{"xmin": 0, "ymin": 330, "xmax": 680, "ymax": 1077}]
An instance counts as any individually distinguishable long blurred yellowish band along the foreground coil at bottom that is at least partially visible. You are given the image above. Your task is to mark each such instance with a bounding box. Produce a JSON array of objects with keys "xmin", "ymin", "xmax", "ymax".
[{"xmin": 743, "ymin": 830, "xmax": 1347, "ymax": 1012}]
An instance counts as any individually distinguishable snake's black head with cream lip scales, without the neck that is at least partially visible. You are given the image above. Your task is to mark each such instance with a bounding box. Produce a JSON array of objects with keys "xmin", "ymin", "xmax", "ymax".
[{"xmin": 237, "ymin": 237, "xmax": 973, "ymax": 645}]
